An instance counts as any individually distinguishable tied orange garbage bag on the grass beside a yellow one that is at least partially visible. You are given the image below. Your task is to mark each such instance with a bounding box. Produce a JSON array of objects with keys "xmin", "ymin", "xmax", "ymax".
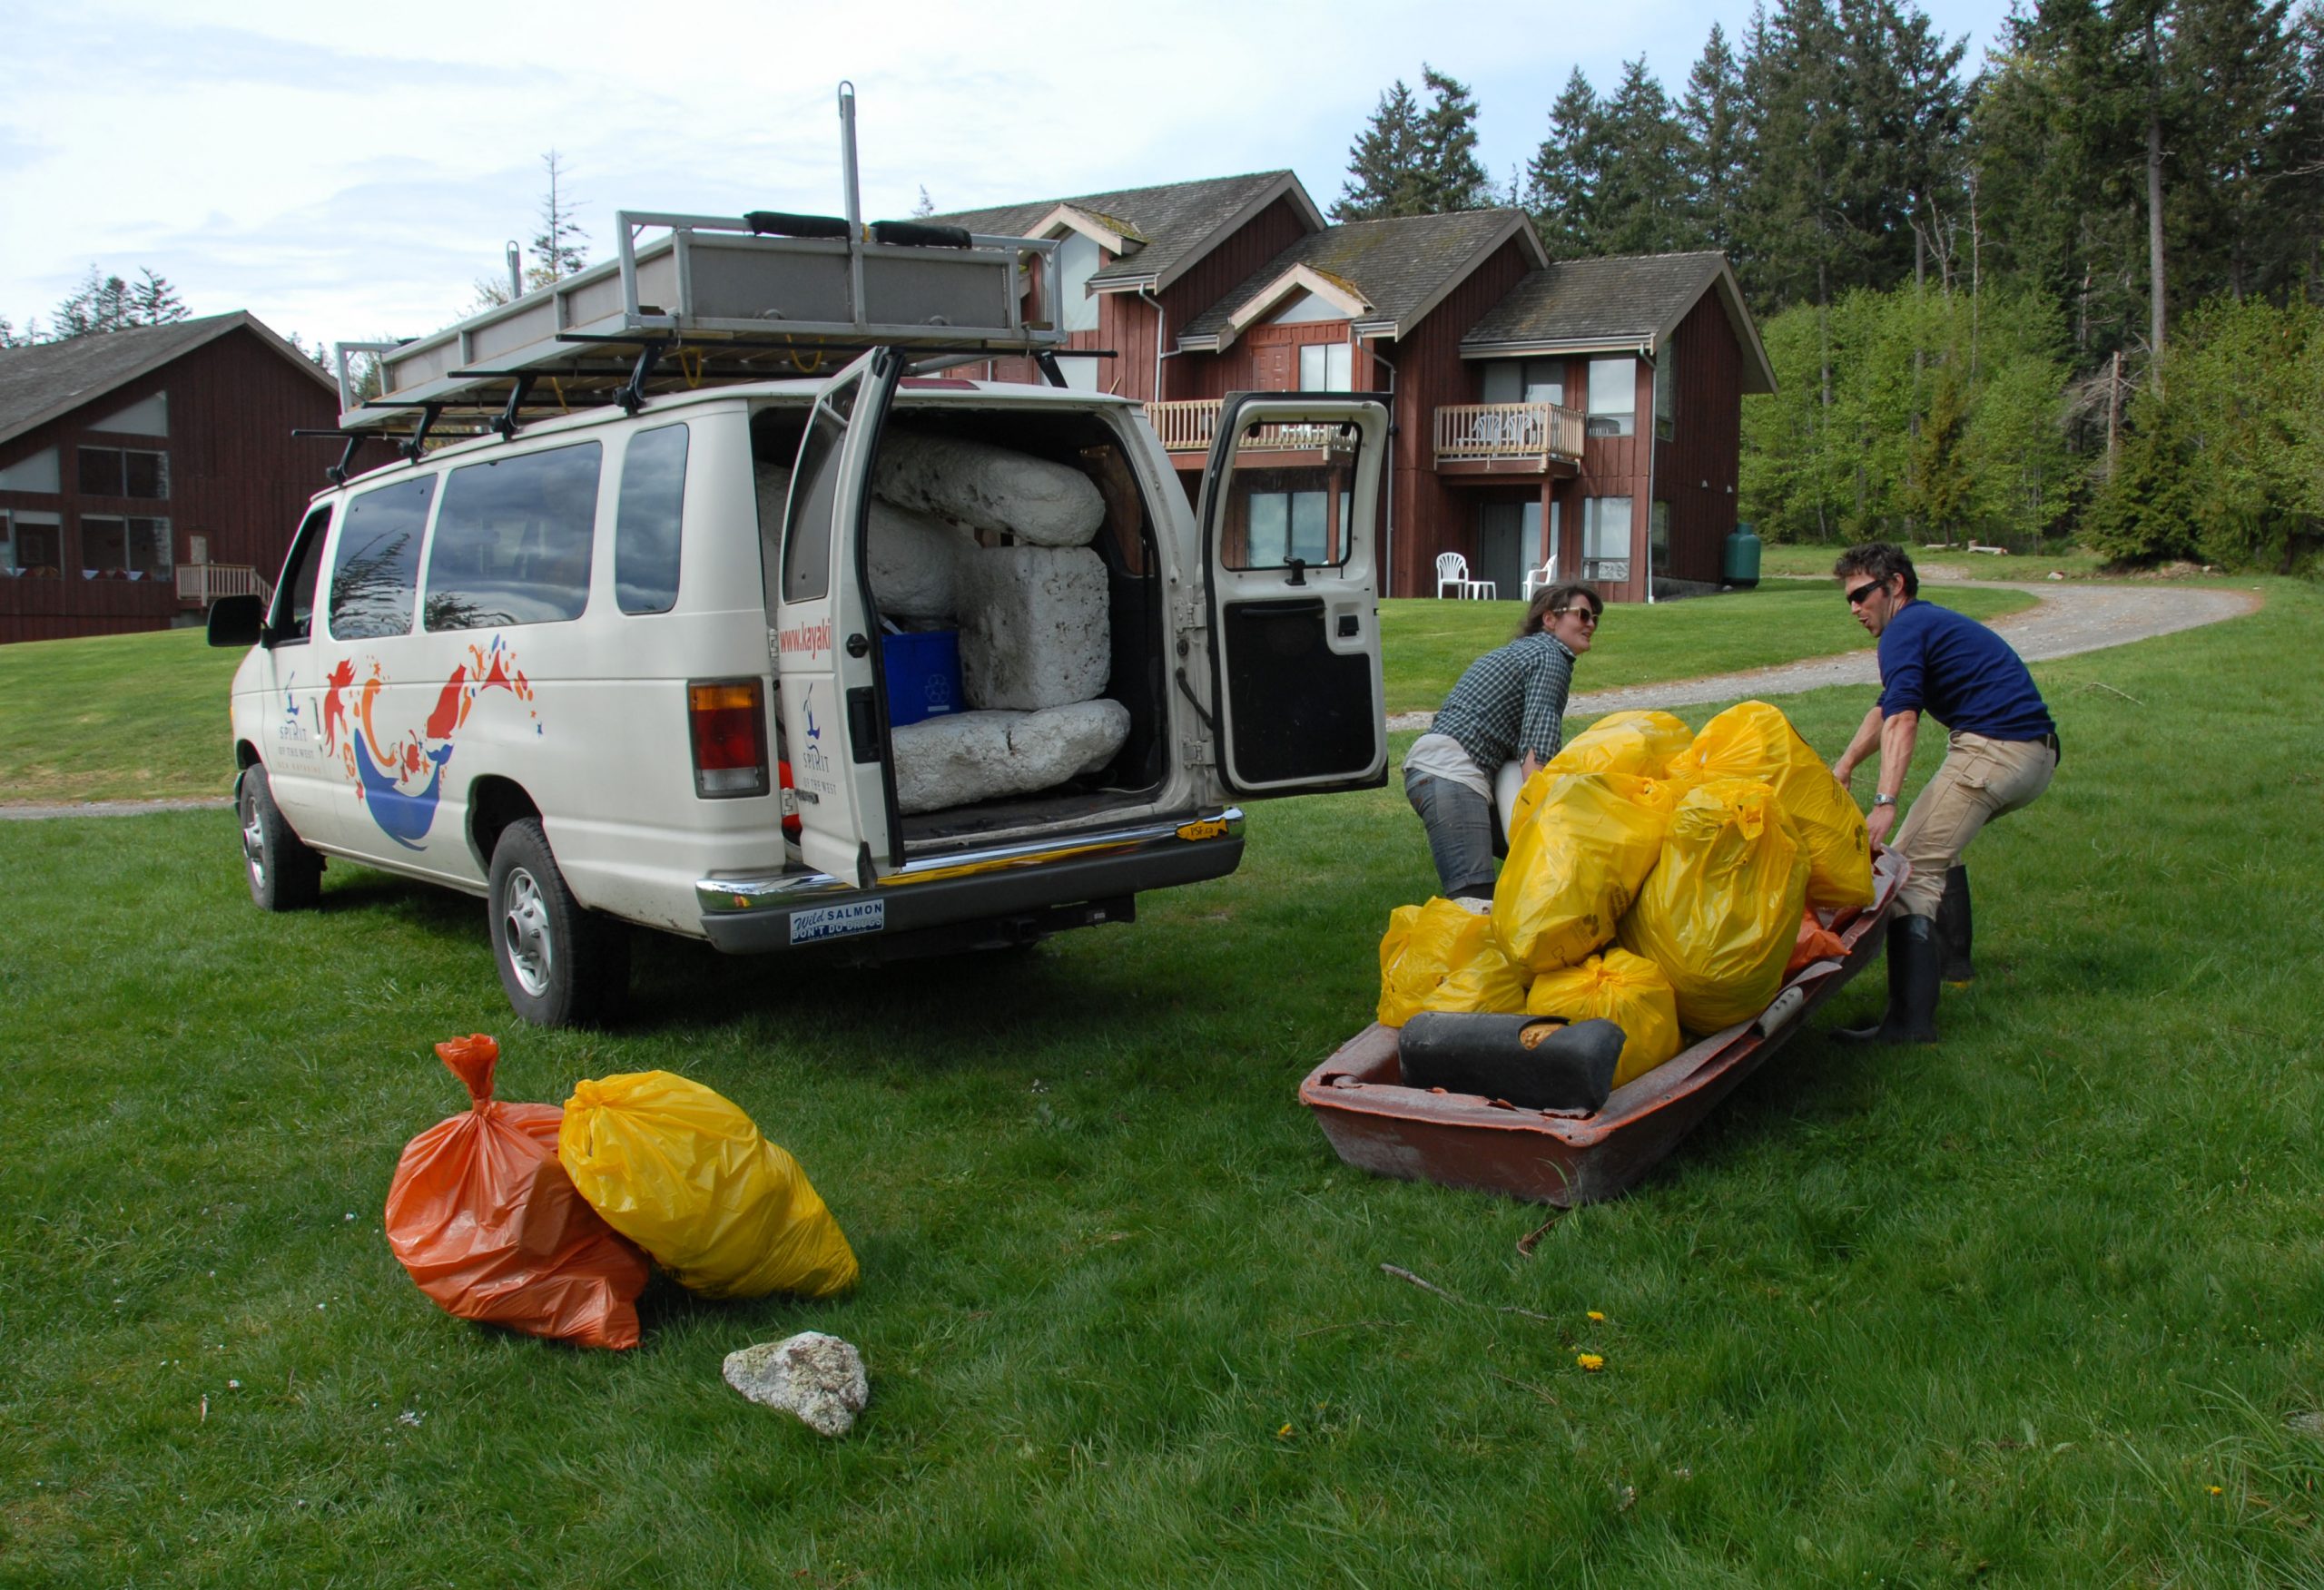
[{"xmin": 389, "ymin": 1032, "xmax": 646, "ymax": 1349}]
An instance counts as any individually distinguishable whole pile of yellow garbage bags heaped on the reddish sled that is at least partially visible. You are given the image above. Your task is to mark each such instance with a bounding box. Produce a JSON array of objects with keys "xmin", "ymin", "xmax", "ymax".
[{"xmin": 1381, "ymin": 702, "xmax": 1873, "ymax": 1085}]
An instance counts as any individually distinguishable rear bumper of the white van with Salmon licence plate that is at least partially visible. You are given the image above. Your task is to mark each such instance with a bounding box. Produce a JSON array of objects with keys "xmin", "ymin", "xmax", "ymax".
[{"xmin": 694, "ymin": 807, "xmax": 1244, "ymax": 956}]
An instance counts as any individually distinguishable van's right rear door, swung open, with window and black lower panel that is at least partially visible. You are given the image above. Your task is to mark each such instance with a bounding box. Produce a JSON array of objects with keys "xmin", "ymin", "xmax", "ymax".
[{"xmin": 1199, "ymin": 393, "xmax": 1387, "ymax": 798}]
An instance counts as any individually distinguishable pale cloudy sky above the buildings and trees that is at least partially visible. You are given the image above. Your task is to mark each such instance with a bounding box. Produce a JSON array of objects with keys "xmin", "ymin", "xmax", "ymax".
[{"xmin": 0, "ymin": 0, "xmax": 2008, "ymax": 347}]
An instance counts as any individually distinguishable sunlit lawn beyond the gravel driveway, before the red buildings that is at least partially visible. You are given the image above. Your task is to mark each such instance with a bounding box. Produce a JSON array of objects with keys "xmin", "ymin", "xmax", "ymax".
[{"xmin": 0, "ymin": 588, "xmax": 2034, "ymax": 804}]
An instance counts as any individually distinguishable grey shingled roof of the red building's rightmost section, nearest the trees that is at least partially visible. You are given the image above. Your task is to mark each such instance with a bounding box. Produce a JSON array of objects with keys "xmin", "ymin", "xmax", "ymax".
[{"xmin": 1460, "ymin": 251, "xmax": 1776, "ymax": 393}]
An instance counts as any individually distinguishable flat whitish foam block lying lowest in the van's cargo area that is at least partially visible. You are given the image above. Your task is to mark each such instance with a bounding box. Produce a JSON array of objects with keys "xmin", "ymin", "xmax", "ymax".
[{"xmin": 890, "ymin": 700, "xmax": 1129, "ymax": 816}]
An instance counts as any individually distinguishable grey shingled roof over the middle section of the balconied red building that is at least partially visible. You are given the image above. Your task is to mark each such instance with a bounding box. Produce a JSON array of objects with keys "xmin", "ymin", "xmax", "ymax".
[{"xmin": 1178, "ymin": 210, "xmax": 1548, "ymax": 353}]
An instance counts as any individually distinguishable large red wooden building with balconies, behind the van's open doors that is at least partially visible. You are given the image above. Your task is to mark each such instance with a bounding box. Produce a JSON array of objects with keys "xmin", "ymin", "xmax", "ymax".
[{"xmin": 939, "ymin": 172, "xmax": 1776, "ymax": 600}]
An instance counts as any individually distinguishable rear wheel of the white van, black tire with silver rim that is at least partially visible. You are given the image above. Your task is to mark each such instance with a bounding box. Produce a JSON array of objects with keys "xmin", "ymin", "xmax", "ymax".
[{"xmin": 488, "ymin": 819, "xmax": 630, "ymax": 1027}]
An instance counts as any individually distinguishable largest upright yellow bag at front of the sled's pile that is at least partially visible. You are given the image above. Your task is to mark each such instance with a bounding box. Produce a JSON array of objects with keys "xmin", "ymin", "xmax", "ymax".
[{"xmin": 1622, "ymin": 779, "xmax": 1808, "ymax": 1032}]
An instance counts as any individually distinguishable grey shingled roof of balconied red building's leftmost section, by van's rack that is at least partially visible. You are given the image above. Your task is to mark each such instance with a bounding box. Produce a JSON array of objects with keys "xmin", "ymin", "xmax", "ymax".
[{"xmin": 930, "ymin": 172, "xmax": 1323, "ymax": 293}]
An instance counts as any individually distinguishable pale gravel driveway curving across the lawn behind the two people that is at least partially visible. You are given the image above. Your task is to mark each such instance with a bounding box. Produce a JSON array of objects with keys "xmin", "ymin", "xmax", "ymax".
[{"xmin": 1387, "ymin": 581, "xmax": 2259, "ymax": 730}]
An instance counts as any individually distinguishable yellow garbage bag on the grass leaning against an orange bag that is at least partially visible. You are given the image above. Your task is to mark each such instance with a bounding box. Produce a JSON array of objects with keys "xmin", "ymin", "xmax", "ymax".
[{"xmin": 557, "ymin": 1072, "xmax": 855, "ymax": 1297}]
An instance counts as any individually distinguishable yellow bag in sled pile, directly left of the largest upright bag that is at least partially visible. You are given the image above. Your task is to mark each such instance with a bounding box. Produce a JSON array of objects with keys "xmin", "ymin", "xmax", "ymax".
[{"xmin": 1492, "ymin": 770, "xmax": 1671, "ymax": 977}]
